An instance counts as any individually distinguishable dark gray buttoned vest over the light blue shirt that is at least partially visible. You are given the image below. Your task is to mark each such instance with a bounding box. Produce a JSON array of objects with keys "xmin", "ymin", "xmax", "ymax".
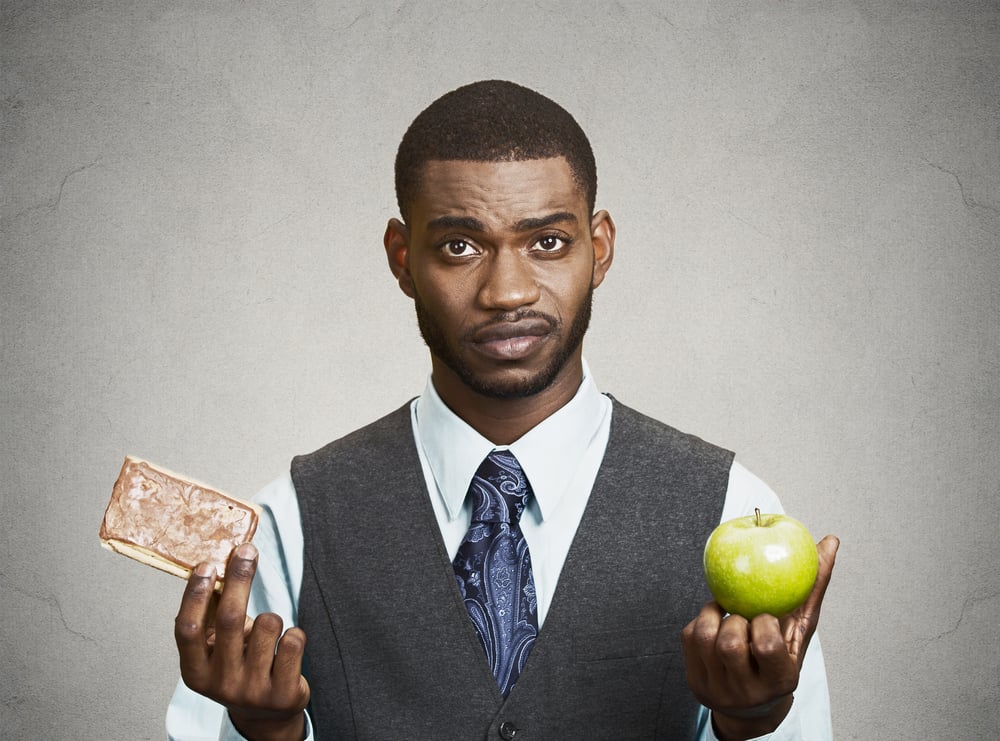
[{"xmin": 292, "ymin": 401, "xmax": 733, "ymax": 741}]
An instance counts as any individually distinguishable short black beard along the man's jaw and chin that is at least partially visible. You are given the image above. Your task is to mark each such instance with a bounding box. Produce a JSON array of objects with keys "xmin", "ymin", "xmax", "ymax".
[{"xmin": 413, "ymin": 286, "xmax": 594, "ymax": 399}]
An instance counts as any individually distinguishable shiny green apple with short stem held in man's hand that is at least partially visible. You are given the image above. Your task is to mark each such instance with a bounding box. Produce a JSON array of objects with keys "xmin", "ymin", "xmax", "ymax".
[{"xmin": 704, "ymin": 509, "xmax": 819, "ymax": 620}]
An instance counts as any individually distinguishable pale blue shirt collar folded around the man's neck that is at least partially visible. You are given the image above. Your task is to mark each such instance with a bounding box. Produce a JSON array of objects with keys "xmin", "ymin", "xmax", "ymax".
[{"xmin": 416, "ymin": 362, "xmax": 610, "ymax": 520}]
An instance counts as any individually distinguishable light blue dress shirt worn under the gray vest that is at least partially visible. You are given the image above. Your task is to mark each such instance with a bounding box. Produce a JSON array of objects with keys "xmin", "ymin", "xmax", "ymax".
[{"xmin": 166, "ymin": 364, "xmax": 833, "ymax": 741}]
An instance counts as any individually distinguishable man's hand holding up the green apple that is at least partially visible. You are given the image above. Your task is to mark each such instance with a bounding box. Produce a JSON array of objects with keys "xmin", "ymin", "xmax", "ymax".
[{"xmin": 681, "ymin": 536, "xmax": 839, "ymax": 741}]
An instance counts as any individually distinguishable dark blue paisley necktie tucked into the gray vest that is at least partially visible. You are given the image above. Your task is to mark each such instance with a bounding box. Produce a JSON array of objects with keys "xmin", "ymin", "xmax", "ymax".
[{"xmin": 453, "ymin": 450, "xmax": 538, "ymax": 697}]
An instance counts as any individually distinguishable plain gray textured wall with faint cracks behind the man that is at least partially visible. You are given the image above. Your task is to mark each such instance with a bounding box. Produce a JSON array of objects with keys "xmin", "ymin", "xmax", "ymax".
[{"xmin": 0, "ymin": 0, "xmax": 1000, "ymax": 739}]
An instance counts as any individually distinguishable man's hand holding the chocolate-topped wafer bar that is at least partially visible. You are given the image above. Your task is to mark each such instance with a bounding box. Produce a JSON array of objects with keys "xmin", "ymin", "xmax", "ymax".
[{"xmin": 174, "ymin": 543, "xmax": 309, "ymax": 741}]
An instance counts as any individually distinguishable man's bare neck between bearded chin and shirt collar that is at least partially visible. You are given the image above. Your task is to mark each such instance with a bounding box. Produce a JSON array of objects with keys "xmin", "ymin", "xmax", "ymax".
[{"xmin": 432, "ymin": 353, "xmax": 583, "ymax": 445}]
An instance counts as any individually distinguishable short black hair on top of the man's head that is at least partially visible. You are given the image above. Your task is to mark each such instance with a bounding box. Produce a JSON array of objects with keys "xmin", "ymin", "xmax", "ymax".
[{"xmin": 396, "ymin": 80, "xmax": 597, "ymax": 221}]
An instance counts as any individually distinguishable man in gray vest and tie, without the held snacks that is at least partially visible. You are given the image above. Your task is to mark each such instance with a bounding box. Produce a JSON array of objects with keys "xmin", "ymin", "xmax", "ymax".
[{"xmin": 167, "ymin": 81, "xmax": 837, "ymax": 740}]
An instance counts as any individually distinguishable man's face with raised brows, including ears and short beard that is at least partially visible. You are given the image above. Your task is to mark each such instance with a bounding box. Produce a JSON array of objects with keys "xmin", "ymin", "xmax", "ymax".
[{"xmin": 387, "ymin": 157, "xmax": 613, "ymax": 399}]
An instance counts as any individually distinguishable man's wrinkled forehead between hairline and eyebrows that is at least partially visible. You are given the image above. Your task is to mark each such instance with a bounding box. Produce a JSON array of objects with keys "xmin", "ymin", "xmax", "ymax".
[{"xmin": 413, "ymin": 157, "xmax": 587, "ymax": 224}]
